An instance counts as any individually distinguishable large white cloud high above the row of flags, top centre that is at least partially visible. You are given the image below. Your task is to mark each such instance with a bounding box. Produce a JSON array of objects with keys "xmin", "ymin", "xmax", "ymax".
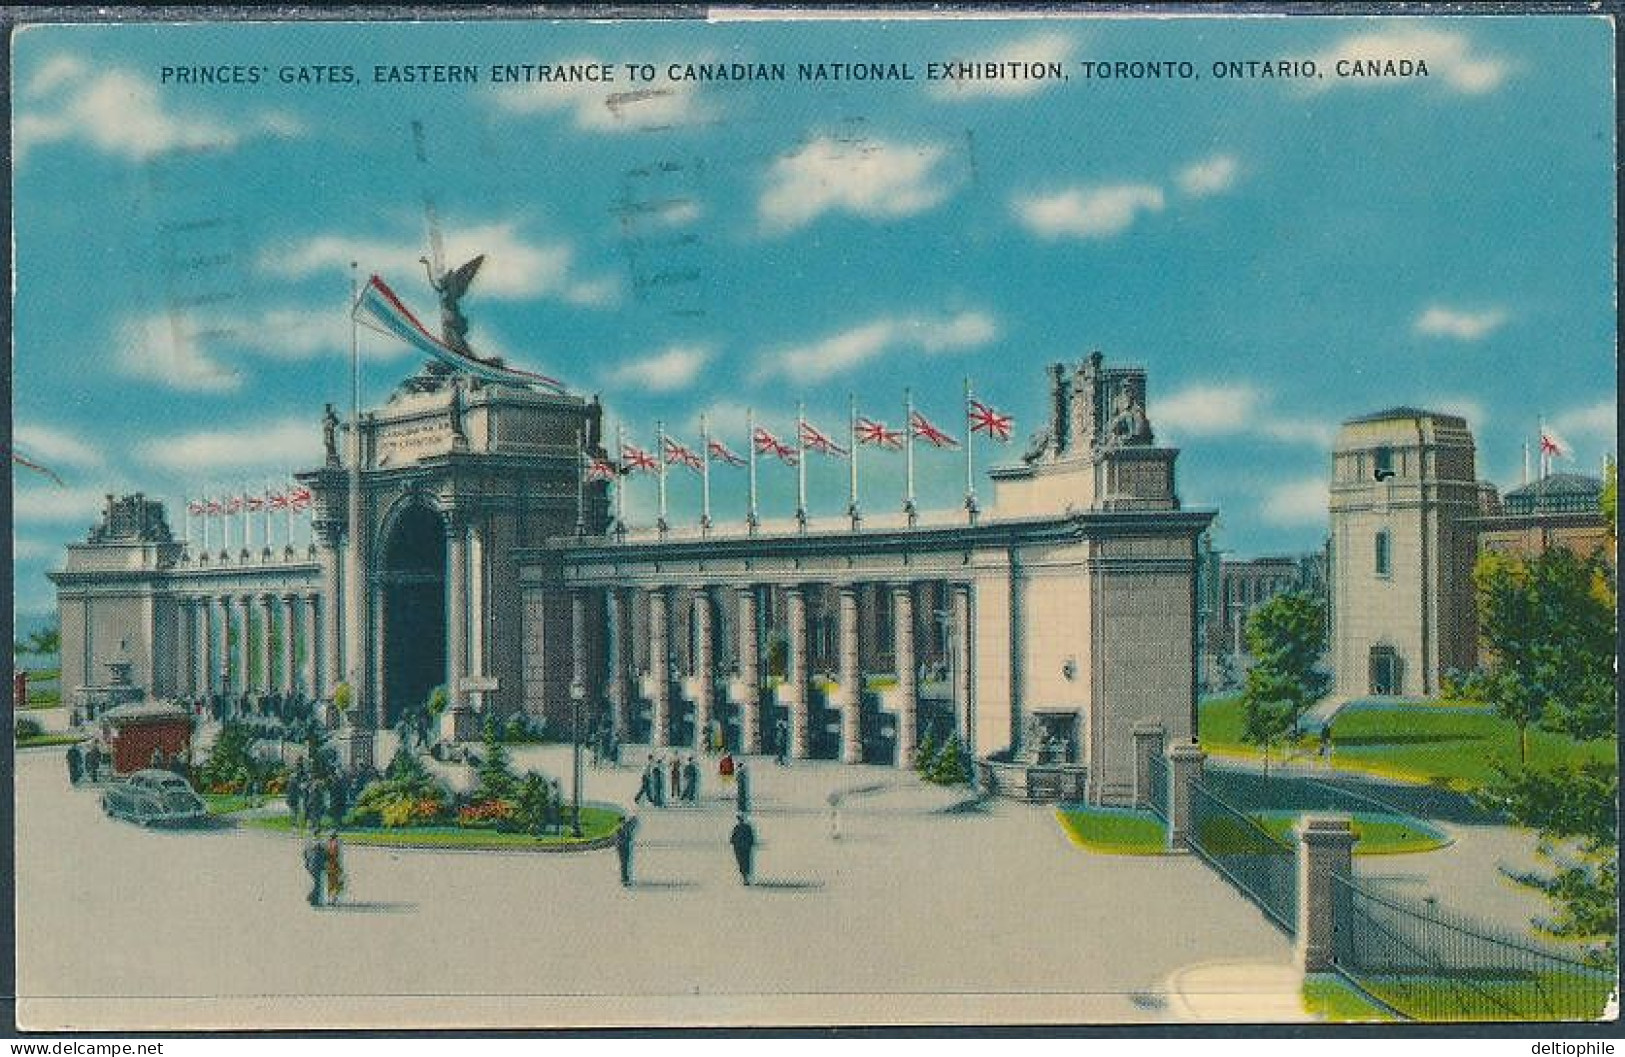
[{"xmin": 756, "ymin": 137, "xmax": 952, "ymax": 234}]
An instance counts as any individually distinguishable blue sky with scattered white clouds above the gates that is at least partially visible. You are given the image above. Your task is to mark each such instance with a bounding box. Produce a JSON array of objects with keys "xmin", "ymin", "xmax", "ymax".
[{"xmin": 13, "ymin": 18, "xmax": 1615, "ymax": 613}]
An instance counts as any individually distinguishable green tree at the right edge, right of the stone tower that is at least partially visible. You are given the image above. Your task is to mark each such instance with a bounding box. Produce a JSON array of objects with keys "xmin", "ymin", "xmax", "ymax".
[{"xmin": 1463, "ymin": 548, "xmax": 1617, "ymax": 766}]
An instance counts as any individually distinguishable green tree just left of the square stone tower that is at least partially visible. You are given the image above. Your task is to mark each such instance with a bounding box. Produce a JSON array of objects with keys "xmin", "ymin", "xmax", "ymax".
[{"xmin": 1242, "ymin": 592, "xmax": 1331, "ymax": 771}]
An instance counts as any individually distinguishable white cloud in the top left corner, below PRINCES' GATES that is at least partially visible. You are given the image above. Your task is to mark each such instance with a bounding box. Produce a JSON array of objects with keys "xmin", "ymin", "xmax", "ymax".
[{"xmin": 13, "ymin": 55, "xmax": 299, "ymax": 161}]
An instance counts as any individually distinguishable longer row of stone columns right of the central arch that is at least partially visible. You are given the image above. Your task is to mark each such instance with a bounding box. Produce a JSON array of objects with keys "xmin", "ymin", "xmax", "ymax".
[{"xmin": 567, "ymin": 581, "xmax": 975, "ymax": 764}]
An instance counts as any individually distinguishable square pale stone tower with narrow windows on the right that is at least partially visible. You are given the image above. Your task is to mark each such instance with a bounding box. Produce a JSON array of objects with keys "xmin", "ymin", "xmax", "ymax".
[{"xmin": 1331, "ymin": 407, "xmax": 1479, "ymax": 698}]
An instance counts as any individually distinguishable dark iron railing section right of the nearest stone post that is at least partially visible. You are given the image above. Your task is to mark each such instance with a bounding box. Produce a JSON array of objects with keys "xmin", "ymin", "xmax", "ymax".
[{"xmin": 1334, "ymin": 878, "xmax": 1619, "ymax": 1021}]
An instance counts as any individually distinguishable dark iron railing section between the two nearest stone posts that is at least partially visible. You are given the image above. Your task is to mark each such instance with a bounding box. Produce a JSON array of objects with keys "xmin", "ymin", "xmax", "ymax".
[{"xmin": 1190, "ymin": 782, "xmax": 1298, "ymax": 935}]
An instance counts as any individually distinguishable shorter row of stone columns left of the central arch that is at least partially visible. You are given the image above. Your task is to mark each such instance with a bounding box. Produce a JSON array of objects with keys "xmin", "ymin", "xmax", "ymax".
[{"xmin": 176, "ymin": 590, "xmax": 332, "ymax": 698}]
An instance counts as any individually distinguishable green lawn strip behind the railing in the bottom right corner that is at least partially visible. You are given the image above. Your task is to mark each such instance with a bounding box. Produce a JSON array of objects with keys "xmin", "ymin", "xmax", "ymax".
[{"xmin": 1360, "ymin": 971, "xmax": 1614, "ymax": 1021}]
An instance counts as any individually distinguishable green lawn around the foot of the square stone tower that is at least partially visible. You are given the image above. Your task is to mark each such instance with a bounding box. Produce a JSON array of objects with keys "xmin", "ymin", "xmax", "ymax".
[{"xmin": 1199, "ymin": 696, "xmax": 1614, "ymax": 790}]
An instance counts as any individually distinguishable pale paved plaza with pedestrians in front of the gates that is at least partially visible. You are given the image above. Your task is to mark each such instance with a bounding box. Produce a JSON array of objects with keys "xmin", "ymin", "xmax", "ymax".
[{"xmin": 16, "ymin": 748, "xmax": 1295, "ymax": 1029}]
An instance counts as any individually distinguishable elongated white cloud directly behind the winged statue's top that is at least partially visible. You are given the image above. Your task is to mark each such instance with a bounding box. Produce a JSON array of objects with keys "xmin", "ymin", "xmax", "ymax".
[{"xmin": 258, "ymin": 223, "xmax": 619, "ymax": 307}]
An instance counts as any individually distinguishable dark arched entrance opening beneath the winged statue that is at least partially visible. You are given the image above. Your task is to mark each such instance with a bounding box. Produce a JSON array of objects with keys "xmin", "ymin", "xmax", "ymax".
[{"xmin": 382, "ymin": 506, "xmax": 445, "ymax": 725}]
